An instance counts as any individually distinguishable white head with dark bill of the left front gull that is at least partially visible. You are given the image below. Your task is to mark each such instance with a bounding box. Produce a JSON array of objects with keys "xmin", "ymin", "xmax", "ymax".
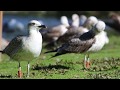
[{"xmin": 28, "ymin": 20, "xmax": 46, "ymax": 30}]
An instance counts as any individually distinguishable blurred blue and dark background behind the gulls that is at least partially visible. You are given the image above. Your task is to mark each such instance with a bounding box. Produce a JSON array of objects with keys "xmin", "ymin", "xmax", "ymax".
[{"xmin": 2, "ymin": 11, "xmax": 120, "ymax": 49}]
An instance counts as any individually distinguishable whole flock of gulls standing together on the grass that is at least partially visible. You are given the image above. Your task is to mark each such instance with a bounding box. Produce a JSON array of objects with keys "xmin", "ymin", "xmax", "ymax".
[{"xmin": 0, "ymin": 14, "xmax": 109, "ymax": 78}]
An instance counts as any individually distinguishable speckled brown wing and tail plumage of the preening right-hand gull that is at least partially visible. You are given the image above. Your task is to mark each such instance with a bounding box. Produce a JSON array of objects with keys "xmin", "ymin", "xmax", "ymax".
[{"xmin": 46, "ymin": 30, "xmax": 95, "ymax": 57}]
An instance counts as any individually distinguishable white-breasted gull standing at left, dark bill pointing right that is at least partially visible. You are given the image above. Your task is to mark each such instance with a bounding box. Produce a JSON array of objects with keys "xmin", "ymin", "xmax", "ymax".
[{"xmin": 0, "ymin": 20, "xmax": 46, "ymax": 78}]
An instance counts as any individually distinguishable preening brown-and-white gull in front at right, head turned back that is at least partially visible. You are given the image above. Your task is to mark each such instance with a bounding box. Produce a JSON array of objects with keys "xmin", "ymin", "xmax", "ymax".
[{"xmin": 45, "ymin": 21, "xmax": 106, "ymax": 69}]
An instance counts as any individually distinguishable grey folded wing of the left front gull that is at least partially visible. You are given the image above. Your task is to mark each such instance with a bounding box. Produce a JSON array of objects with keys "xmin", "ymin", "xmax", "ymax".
[{"xmin": 3, "ymin": 36, "xmax": 23, "ymax": 56}]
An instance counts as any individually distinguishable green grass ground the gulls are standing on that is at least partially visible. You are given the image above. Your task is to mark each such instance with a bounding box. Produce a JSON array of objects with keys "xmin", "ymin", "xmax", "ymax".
[{"xmin": 0, "ymin": 29, "xmax": 120, "ymax": 79}]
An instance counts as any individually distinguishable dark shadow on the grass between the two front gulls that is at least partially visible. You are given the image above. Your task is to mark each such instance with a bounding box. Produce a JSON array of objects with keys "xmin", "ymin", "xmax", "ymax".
[{"xmin": 32, "ymin": 65, "xmax": 70, "ymax": 70}]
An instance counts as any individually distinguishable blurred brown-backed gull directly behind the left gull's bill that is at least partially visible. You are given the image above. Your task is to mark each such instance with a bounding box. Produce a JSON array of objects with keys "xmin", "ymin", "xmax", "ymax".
[{"xmin": 42, "ymin": 16, "xmax": 70, "ymax": 47}]
